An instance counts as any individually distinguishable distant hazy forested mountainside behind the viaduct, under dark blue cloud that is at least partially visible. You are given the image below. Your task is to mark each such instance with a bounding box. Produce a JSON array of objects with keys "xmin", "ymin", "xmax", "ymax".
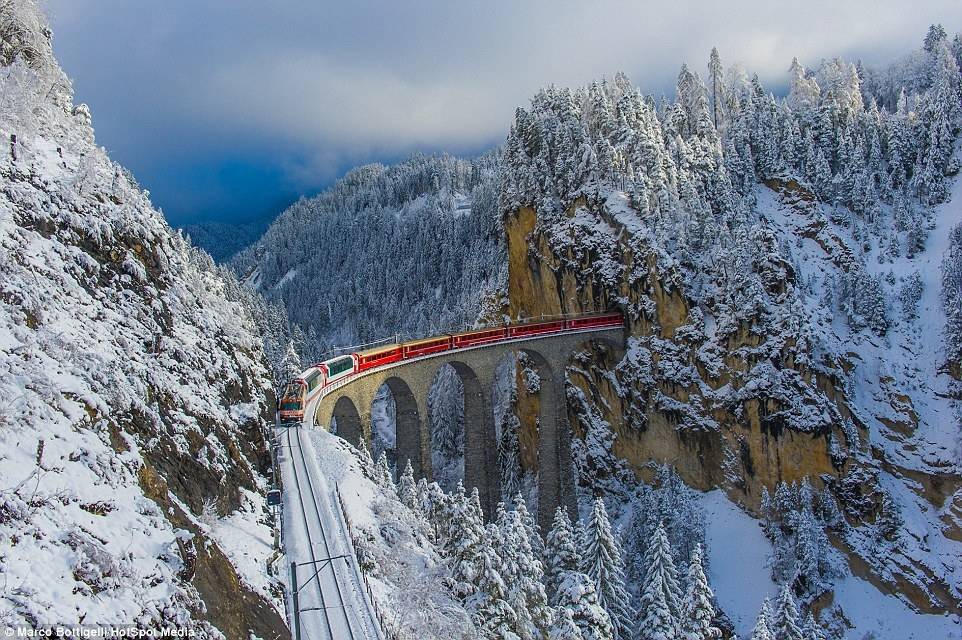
[{"xmin": 231, "ymin": 153, "xmax": 504, "ymax": 360}]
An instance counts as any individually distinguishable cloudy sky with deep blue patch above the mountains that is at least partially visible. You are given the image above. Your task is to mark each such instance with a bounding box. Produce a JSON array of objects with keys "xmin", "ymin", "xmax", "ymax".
[{"xmin": 47, "ymin": 0, "xmax": 962, "ymax": 224}]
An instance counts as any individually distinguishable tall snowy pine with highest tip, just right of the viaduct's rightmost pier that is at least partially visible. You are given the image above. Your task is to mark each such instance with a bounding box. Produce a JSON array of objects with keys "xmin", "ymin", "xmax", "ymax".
[{"xmin": 583, "ymin": 498, "xmax": 632, "ymax": 640}]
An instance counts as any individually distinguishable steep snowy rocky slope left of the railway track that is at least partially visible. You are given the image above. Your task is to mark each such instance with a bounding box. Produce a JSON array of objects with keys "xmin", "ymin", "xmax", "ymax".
[{"xmin": 0, "ymin": 2, "xmax": 289, "ymax": 638}]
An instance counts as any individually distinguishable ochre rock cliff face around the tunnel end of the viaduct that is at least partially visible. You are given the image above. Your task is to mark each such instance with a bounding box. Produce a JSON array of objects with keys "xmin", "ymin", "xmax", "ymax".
[{"xmin": 505, "ymin": 199, "xmax": 850, "ymax": 509}]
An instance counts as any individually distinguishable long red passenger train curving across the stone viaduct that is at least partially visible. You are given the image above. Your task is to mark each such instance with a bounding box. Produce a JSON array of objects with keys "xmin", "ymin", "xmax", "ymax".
[{"xmin": 278, "ymin": 313, "xmax": 624, "ymax": 423}]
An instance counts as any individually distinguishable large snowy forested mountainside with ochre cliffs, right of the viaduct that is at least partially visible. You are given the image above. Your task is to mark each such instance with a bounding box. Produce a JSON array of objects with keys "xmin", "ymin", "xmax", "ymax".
[{"xmin": 501, "ymin": 26, "xmax": 962, "ymax": 637}]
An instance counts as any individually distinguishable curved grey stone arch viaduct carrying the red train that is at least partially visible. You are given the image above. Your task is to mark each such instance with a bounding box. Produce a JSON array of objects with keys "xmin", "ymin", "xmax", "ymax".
[{"xmin": 305, "ymin": 316, "xmax": 625, "ymax": 528}]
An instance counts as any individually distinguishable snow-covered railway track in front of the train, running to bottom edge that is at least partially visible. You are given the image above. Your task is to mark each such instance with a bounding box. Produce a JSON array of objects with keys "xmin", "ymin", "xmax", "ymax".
[{"xmin": 286, "ymin": 427, "xmax": 370, "ymax": 640}]
